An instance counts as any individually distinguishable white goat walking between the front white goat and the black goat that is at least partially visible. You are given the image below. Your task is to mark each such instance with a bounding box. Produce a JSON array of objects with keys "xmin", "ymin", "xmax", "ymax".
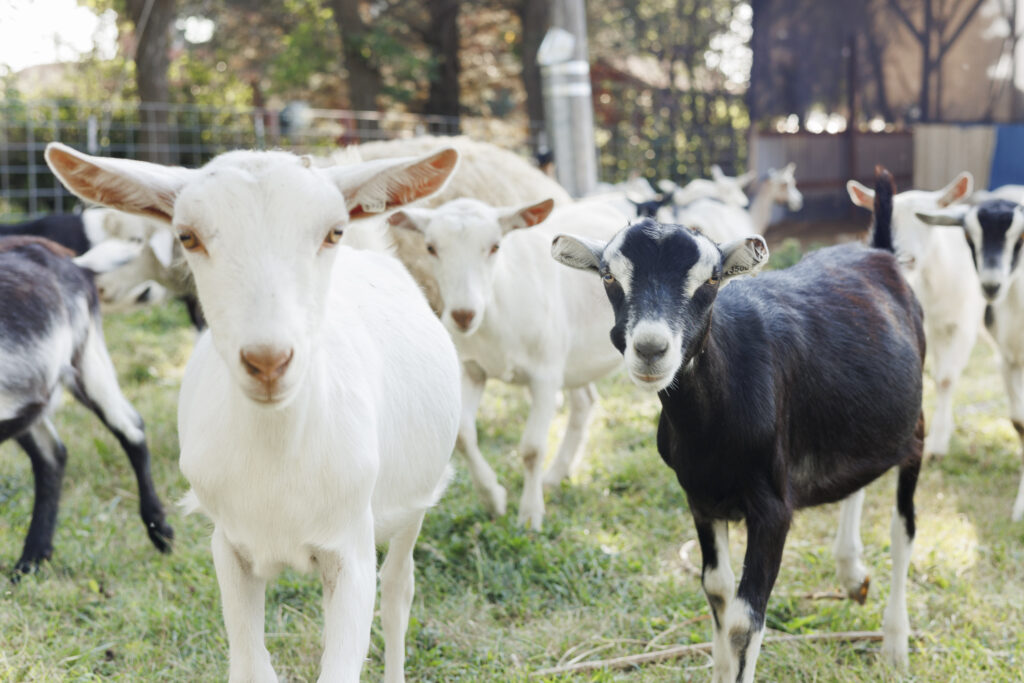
[{"xmin": 388, "ymin": 199, "xmax": 628, "ymax": 529}]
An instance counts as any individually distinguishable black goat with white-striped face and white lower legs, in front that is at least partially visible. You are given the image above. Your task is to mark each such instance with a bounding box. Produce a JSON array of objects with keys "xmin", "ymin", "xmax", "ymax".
[{"xmin": 552, "ymin": 169, "xmax": 925, "ymax": 682}]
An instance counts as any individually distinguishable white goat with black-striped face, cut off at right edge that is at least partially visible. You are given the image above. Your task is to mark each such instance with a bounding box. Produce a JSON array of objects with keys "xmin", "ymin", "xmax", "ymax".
[{"xmin": 916, "ymin": 199, "xmax": 1024, "ymax": 521}]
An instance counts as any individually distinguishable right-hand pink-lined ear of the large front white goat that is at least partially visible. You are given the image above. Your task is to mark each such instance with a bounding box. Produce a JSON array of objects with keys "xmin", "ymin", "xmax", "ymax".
[{"xmin": 326, "ymin": 147, "xmax": 459, "ymax": 220}]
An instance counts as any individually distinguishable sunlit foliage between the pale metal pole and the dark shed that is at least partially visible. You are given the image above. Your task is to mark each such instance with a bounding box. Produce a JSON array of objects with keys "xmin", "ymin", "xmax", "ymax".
[{"xmin": 589, "ymin": 0, "xmax": 750, "ymax": 181}]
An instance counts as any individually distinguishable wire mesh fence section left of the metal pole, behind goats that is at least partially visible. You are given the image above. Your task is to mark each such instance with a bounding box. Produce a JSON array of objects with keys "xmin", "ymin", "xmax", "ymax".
[{"xmin": 0, "ymin": 100, "xmax": 544, "ymax": 222}]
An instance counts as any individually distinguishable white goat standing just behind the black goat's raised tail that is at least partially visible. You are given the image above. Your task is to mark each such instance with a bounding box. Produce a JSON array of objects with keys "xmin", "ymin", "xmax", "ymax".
[{"xmin": 846, "ymin": 172, "xmax": 985, "ymax": 457}]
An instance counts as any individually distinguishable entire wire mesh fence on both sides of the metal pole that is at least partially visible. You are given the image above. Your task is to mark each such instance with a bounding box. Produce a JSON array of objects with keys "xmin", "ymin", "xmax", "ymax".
[{"xmin": 0, "ymin": 93, "xmax": 748, "ymax": 222}]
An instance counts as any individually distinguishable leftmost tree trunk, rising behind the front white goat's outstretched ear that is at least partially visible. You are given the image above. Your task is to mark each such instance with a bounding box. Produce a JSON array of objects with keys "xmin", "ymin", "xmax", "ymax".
[{"xmin": 127, "ymin": 0, "xmax": 177, "ymax": 164}]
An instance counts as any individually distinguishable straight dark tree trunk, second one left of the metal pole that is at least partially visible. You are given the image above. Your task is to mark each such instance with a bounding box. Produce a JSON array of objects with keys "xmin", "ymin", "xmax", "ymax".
[{"xmin": 424, "ymin": 0, "xmax": 460, "ymax": 134}]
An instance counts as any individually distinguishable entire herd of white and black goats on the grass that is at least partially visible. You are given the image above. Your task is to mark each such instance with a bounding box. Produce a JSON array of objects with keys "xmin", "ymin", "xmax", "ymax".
[{"xmin": 0, "ymin": 138, "xmax": 1024, "ymax": 683}]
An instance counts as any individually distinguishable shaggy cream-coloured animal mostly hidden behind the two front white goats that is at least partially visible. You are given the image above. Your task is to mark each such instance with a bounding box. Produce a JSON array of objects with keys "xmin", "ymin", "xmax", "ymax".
[{"xmin": 331, "ymin": 136, "xmax": 572, "ymax": 314}]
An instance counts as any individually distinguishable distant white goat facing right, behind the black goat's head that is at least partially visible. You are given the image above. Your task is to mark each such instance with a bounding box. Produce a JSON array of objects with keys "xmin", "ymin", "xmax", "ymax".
[{"xmin": 674, "ymin": 164, "xmax": 804, "ymax": 243}]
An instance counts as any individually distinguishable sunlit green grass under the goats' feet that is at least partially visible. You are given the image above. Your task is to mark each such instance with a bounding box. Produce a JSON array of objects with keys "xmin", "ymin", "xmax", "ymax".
[{"xmin": 0, "ymin": 294, "xmax": 1024, "ymax": 683}]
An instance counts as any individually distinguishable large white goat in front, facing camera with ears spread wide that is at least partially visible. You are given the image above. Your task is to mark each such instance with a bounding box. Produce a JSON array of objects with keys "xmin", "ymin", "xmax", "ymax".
[{"xmin": 46, "ymin": 143, "xmax": 459, "ymax": 683}]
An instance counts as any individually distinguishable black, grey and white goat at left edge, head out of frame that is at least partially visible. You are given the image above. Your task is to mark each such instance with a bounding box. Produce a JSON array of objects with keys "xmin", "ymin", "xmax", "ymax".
[{"xmin": 0, "ymin": 237, "xmax": 174, "ymax": 572}]
